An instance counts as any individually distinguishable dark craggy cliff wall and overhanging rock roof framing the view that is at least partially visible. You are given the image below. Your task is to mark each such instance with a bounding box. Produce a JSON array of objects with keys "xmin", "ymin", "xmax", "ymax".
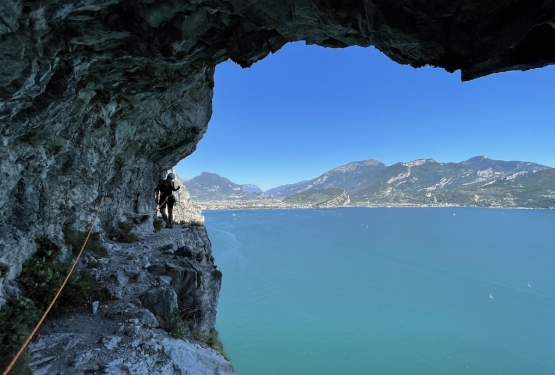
[{"xmin": 0, "ymin": 0, "xmax": 555, "ymax": 280}]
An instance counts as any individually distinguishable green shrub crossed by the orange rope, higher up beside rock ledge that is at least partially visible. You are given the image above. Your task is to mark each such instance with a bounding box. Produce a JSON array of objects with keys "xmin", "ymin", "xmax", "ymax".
[{"xmin": 19, "ymin": 238, "xmax": 94, "ymax": 315}]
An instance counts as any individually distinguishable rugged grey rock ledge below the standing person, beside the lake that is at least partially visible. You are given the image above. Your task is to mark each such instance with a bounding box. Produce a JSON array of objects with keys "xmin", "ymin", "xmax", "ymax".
[{"xmin": 29, "ymin": 225, "xmax": 235, "ymax": 375}]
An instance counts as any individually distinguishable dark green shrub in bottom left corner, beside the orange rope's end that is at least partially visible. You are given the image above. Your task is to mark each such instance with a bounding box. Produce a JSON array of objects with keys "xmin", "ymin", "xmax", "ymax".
[{"xmin": 0, "ymin": 297, "xmax": 40, "ymax": 375}]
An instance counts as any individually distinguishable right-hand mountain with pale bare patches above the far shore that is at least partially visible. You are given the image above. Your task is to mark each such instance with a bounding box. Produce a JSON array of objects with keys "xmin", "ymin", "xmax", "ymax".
[{"xmin": 346, "ymin": 156, "xmax": 555, "ymax": 207}]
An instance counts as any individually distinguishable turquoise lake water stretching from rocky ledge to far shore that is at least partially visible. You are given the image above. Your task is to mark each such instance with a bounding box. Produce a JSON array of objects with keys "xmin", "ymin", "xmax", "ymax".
[{"xmin": 203, "ymin": 208, "xmax": 555, "ymax": 375}]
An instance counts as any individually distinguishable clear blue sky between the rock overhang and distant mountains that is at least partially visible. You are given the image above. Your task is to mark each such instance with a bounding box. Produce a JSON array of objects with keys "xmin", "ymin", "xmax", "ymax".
[{"xmin": 176, "ymin": 42, "xmax": 555, "ymax": 190}]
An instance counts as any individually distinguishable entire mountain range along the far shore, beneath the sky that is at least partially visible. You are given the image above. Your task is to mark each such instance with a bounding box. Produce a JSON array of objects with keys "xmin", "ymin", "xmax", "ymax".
[{"xmin": 186, "ymin": 156, "xmax": 555, "ymax": 207}]
